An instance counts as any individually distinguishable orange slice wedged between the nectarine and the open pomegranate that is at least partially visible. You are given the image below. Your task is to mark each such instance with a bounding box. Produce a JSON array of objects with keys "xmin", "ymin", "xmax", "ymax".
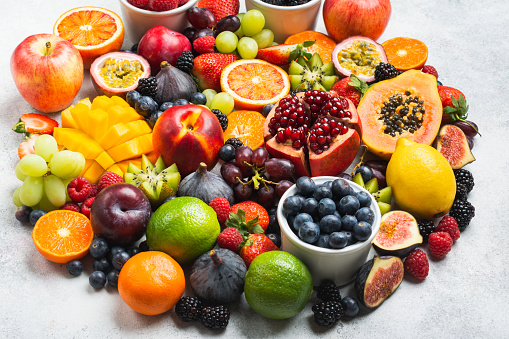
[{"xmin": 223, "ymin": 110, "xmax": 265, "ymax": 149}]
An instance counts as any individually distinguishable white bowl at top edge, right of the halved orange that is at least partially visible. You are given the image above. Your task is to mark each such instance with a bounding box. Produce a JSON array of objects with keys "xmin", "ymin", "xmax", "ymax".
[{"xmin": 120, "ymin": 0, "xmax": 198, "ymax": 43}]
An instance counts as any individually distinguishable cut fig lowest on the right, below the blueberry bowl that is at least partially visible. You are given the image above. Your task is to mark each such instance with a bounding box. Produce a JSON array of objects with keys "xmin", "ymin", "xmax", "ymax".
[{"xmin": 354, "ymin": 255, "xmax": 404, "ymax": 308}]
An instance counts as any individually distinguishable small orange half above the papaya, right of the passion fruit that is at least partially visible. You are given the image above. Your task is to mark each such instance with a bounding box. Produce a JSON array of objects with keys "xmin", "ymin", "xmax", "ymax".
[{"xmin": 382, "ymin": 37, "xmax": 428, "ymax": 71}]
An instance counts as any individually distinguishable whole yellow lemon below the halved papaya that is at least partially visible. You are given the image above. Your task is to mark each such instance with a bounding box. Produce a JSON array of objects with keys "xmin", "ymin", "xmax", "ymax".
[{"xmin": 386, "ymin": 138, "xmax": 456, "ymax": 219}]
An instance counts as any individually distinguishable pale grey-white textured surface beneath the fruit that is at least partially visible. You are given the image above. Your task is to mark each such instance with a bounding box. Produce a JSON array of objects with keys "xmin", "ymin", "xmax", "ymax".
[{"xmin": 0, "ymin": 0, "xmax": 509, "ymax": 338}]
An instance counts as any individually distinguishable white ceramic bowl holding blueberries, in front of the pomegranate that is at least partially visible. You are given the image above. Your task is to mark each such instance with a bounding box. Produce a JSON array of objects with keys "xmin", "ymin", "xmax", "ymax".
[{"xmin": 277, "ymin": 176, "xmax": 382, "ymax": 286}]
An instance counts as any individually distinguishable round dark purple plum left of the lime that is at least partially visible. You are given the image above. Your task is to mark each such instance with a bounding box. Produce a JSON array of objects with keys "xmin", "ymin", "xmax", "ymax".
[{"xmin": 90, "ymin": 183, "xmax": 152, "ymax": 246}]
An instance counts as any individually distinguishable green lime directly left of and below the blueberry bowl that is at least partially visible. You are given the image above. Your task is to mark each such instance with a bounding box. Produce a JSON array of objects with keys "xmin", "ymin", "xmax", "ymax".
[{"xmin": 244, "ymin": 251, "xmax": 313, "ymax": 319}]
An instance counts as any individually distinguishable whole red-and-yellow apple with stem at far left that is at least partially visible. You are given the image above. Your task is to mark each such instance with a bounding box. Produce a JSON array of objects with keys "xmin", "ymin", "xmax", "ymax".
[{"xmin": 11, "ymin": 34, "xmax": 83, "ymax": 113}]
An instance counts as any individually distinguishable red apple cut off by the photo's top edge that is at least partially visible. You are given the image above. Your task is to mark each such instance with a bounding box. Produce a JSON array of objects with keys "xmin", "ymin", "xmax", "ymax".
[{"xmin": 323, "ymin": 0, "xmax": 391, "ymax": 42}]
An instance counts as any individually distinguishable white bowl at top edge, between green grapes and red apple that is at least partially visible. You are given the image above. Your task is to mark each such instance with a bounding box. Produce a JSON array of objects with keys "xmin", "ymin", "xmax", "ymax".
[{"xmin": 246, "ymin": 0, "xmax": 321, "ymax": 44}]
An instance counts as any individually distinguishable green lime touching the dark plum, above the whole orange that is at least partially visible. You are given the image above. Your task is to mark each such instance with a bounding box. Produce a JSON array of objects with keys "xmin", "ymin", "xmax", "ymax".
[{"xmin": 146, "ymin": 197, "xmax": 221, "ymax": 264}]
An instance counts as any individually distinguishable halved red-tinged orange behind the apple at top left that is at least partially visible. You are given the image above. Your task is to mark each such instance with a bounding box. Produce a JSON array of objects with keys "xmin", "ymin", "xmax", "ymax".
[{"xmin": 53, "ymin": 6, "xmax": 124, "ymax": 69}]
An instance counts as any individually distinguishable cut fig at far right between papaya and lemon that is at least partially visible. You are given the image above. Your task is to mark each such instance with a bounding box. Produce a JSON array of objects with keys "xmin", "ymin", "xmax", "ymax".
[{"xmin": 435, "ymin": 125, "xmax": 475, "ymax": 169}]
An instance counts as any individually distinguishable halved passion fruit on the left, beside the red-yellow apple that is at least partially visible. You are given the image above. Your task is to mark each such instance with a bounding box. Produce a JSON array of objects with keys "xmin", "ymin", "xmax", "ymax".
[{"xmin": 90, "ymin": 52, "xmax": 150, "ymax": 98}]
